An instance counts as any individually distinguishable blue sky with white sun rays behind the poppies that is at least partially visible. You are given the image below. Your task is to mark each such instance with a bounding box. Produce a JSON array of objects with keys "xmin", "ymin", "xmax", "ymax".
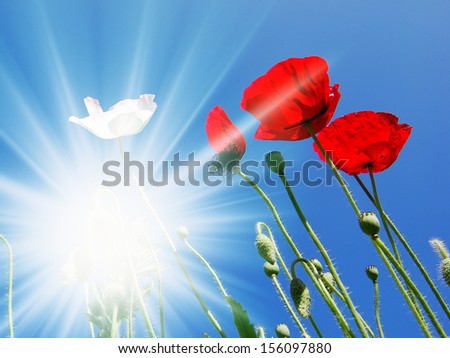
[{"xmin": 0, "ymin": 0, "xmax": 450, "ymax": 337}]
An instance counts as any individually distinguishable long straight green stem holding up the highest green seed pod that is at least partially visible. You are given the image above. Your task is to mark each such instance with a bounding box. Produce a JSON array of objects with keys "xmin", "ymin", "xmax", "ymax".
[{"xmin": 279, "ymin": 174, "xmax": 369, "ymax": 338}]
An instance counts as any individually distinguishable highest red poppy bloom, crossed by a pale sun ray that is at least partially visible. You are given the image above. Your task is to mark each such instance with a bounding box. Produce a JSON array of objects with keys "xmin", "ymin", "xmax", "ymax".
[{"xmin": 241, "ymin": 57, "xmax": 341, "ymax": 140}]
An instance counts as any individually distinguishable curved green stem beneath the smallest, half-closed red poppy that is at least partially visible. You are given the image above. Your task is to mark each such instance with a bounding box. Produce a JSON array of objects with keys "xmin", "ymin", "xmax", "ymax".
[{"xmin": 234, "ymin": 167, "xmax": 355, "ymax": 337}]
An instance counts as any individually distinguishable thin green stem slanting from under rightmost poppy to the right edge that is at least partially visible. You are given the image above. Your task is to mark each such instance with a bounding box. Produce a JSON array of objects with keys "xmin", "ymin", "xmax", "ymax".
[{"xmin": 354, "ymin": 175, "xmax": 450, "ymax": 318}]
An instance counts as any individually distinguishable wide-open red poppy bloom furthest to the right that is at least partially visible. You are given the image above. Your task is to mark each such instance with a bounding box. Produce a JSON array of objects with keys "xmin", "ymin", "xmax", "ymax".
[{"xmin": 314, "ymin": 111, "xmax": 412, "ymax": 175}]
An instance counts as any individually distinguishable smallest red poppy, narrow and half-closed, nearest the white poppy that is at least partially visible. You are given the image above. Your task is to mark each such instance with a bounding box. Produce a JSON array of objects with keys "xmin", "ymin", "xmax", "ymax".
[{"xmin": 206, "ymin": 106, "xmax": 246, "ymax": 160}]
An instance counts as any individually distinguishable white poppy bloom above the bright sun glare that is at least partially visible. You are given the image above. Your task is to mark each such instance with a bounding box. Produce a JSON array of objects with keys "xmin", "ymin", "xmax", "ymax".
[{"xmin": 69, "ymin": 94, "xmax": 157, "ymax": 139}]
